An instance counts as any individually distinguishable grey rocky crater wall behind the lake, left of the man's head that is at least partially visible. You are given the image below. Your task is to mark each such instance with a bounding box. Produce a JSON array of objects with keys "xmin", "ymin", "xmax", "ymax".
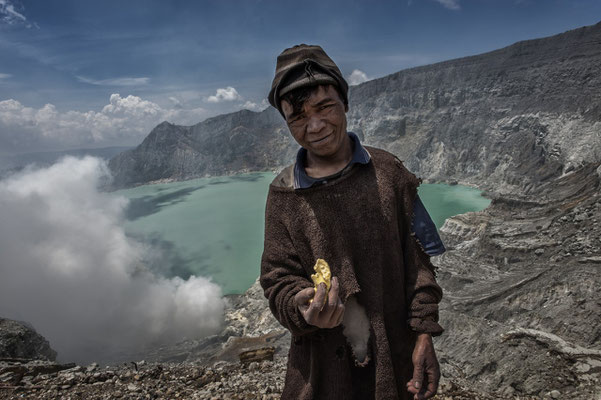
[{"xmin": 109, "ymin": 108, "xmax": 294, "ymax": 187}]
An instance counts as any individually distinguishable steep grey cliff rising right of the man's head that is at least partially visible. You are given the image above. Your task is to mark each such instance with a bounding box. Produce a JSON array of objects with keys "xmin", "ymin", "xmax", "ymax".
[{"xmin": 349, "ymin": 24, "xmax": 601, "ymax": 194}]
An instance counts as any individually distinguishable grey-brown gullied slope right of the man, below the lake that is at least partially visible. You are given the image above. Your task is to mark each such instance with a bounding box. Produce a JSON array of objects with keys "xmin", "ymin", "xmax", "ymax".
[{"xmin": 435, "ymin": 165, "xmax": 601, "ymax": 399}]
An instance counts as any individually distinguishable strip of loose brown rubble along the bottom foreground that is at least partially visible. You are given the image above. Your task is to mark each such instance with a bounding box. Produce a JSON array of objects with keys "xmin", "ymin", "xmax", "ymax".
[{"xmin": 0, "ymin": 357, "xmax": 544, "ymax": 400}]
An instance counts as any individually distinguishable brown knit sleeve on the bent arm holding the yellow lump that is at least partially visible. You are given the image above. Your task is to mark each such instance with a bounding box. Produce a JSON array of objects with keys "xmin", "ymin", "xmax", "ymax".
[{"xmin": 259, "ymin": 188, "xmax": 318, "ymax": 336}]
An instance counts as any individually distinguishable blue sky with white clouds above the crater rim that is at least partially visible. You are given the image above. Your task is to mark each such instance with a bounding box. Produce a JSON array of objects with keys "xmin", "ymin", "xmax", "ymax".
[{"xmin": 0, "ymin": 0, "xmax": 601, "ymax": 154}]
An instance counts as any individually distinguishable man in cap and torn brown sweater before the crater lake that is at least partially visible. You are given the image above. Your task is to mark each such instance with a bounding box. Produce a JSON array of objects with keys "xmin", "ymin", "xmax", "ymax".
[{"xmin": 260, "ymin": 45, "xmax": 444, "ymax": 399}]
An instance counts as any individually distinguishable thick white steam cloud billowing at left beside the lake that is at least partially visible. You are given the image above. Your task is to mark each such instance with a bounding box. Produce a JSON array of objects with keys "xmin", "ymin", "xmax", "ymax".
[{"xmin": 0, "ymin": 157, "xmax": 223, "ymax": 363}]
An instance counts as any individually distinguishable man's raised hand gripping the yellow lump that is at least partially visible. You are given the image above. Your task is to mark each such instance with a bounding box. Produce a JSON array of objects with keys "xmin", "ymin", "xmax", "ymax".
[{"xmin": 294, "ymin": 277, "xmax": 344, "ymax": 328}]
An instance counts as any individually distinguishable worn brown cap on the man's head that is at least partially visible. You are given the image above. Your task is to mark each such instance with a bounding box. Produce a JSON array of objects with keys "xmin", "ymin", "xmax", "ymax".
[{"xmin": 268, "ymin": 44, "xmax": 348, "ymax": 115}]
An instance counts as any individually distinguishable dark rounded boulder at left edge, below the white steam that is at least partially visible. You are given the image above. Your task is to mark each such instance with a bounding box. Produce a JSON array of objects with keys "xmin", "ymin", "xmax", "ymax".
[{"xmin": 0, "ymin": 318, "xmax": 56, "ymax": 361}]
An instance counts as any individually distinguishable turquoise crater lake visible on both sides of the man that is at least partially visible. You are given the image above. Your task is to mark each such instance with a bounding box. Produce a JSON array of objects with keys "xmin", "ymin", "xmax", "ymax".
[{"xmin": 115, "ymin": 173, "xmax": 490, "ymax": 294}]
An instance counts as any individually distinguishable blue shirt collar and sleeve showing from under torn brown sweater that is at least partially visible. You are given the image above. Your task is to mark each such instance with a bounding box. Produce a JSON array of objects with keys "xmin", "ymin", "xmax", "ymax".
[{"xmin": 294, "ymin": 132, "xmax": 446, "ymax": 256}]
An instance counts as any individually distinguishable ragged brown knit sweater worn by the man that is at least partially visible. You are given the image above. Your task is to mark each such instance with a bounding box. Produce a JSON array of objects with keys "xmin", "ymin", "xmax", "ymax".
[{"xmin": 260, "ymin": 148, "xmax": 442, "ymax": 400}]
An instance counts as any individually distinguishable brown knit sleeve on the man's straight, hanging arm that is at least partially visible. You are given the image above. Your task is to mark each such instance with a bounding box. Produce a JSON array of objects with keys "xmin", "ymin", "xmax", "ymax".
[{"xmin": 398, "ymin": 161, "xmax": 444, "ymax": 336}]
